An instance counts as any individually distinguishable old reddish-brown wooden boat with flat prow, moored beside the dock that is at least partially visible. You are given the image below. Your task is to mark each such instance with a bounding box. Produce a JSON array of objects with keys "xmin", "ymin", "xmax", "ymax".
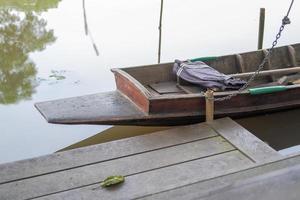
[{"xmin": 35, "ymin": 44, "xmax": 300, "ymax": 125}]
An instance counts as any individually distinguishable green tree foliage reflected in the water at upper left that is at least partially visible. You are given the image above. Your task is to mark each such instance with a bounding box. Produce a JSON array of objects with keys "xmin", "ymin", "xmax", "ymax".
[{"xmin": 0, "ymin": 0, "xmax": 60, "ymax": 104}]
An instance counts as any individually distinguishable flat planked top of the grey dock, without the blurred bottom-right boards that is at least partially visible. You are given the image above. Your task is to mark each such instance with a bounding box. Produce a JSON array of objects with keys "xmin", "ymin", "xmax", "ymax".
[{"xmin": 0, "ymin": 119, "xmax": 279, "ymax": 200}]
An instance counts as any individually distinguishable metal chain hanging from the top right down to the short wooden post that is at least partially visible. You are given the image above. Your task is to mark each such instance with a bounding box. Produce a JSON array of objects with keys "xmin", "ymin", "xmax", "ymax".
[{"xmin": 212, "ymin": 0, "xmax": 294, "ymax": 101}]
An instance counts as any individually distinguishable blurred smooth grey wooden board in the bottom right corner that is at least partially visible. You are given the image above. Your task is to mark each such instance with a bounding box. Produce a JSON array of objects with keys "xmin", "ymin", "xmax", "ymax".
[{"xmin": 203, "ymin": 165, "xmax": 300, "ymax": 200}]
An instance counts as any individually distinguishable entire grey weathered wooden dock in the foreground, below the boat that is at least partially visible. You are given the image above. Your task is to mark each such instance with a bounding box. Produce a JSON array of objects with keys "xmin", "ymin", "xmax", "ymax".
[{"xmin": 0, "ymin": 118, "xmax": 300, "ymax": 200}]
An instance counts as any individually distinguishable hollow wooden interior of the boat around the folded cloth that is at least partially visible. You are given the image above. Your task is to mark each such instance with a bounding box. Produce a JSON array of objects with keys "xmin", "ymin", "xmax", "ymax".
[{"xmin": 122, "ymin": 44, "xmax": 300, "ymax": 97}]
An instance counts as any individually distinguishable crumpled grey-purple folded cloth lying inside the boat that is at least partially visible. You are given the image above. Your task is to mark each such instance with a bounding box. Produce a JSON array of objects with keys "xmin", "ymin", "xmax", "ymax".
[{"xmin": 173, "ymin": 60, "xmax": 246, "ymax": 90}]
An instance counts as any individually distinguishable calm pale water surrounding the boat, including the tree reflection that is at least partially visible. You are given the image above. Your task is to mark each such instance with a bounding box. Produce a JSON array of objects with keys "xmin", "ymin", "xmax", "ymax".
[{"xmin": 0, "ymin": 0, "xmax": 300, "ymax": 163}]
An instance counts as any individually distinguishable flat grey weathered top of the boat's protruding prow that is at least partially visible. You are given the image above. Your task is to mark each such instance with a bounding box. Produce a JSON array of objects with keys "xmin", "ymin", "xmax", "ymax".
[{"xmin": 35, "ymin": 91, "xmax": 145, "ymax": 123}]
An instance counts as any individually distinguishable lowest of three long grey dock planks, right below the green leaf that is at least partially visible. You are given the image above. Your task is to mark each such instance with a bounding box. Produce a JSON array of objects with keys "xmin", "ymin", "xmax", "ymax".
[{"xmin": 35, "ymin": 151, "xmax": 253, "ymax": 200}]
